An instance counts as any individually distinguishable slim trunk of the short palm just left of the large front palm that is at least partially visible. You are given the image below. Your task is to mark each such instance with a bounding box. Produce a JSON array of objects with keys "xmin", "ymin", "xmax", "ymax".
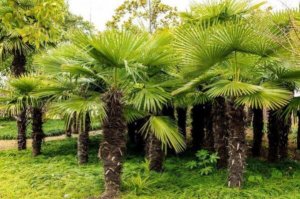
[{"xmin": 77, "ymin": 113, "xmax": 91, "ymax": 164}]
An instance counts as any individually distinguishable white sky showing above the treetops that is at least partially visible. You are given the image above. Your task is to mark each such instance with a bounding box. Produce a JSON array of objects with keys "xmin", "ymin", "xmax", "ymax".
[{"xmin": 67, "ymin": 0, "xmax": 300, "ymax": 30}]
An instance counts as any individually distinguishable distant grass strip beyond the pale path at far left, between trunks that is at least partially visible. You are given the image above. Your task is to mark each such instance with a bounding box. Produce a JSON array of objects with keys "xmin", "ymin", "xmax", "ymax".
[{"xmin": 0, "ymin": 120, "xmax": 64, "ymax": 140}]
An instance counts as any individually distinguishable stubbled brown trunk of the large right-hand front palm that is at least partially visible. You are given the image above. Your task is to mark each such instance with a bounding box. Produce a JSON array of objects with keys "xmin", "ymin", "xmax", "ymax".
[{"xmin": 228, "ymin": 99, "xmax": 246, "ymax": 188}]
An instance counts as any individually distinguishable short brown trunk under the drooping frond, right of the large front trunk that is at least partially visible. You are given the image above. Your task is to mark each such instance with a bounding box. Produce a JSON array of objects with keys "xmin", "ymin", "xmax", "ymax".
[{"xmin": 146, "ymin": 133, "xmax": 165, "ymax": 172}]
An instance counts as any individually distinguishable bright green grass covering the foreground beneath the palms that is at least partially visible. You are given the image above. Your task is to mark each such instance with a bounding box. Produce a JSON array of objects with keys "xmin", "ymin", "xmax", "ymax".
[{"xmin": 0, "ymin": 137, "xmax": 300, "ymax": 199}]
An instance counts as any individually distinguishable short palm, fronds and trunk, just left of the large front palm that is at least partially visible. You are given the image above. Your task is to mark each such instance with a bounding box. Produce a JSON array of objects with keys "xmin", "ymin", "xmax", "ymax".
[{"xmin": 34, "ymin": 74, "xmax": 105, "ymax": 164}]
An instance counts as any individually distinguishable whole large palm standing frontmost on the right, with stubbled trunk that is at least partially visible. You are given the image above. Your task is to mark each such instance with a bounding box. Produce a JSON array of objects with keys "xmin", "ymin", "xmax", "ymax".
[{"xmin": 175, "ymin": 5, "xmax": 291, "ymax": 187}]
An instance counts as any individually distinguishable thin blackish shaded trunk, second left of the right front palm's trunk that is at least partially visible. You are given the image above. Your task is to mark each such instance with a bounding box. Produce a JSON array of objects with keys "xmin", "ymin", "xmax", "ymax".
[{"xmin": 203, "ymin": 102, "xmax": 215, "ymax": 152}]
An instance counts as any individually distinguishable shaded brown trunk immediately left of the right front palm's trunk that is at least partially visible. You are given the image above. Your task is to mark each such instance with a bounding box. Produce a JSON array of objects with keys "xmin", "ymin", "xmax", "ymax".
[{"xmin": 212, "ymin": 97, "xmax": 228, "ymax": 169}]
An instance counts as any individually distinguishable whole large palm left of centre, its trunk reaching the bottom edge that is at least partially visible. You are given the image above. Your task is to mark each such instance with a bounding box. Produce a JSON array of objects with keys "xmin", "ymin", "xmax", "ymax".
[{"xmin": 36, "ymin": 30, "xmax": 184, "ymax": 198}]
